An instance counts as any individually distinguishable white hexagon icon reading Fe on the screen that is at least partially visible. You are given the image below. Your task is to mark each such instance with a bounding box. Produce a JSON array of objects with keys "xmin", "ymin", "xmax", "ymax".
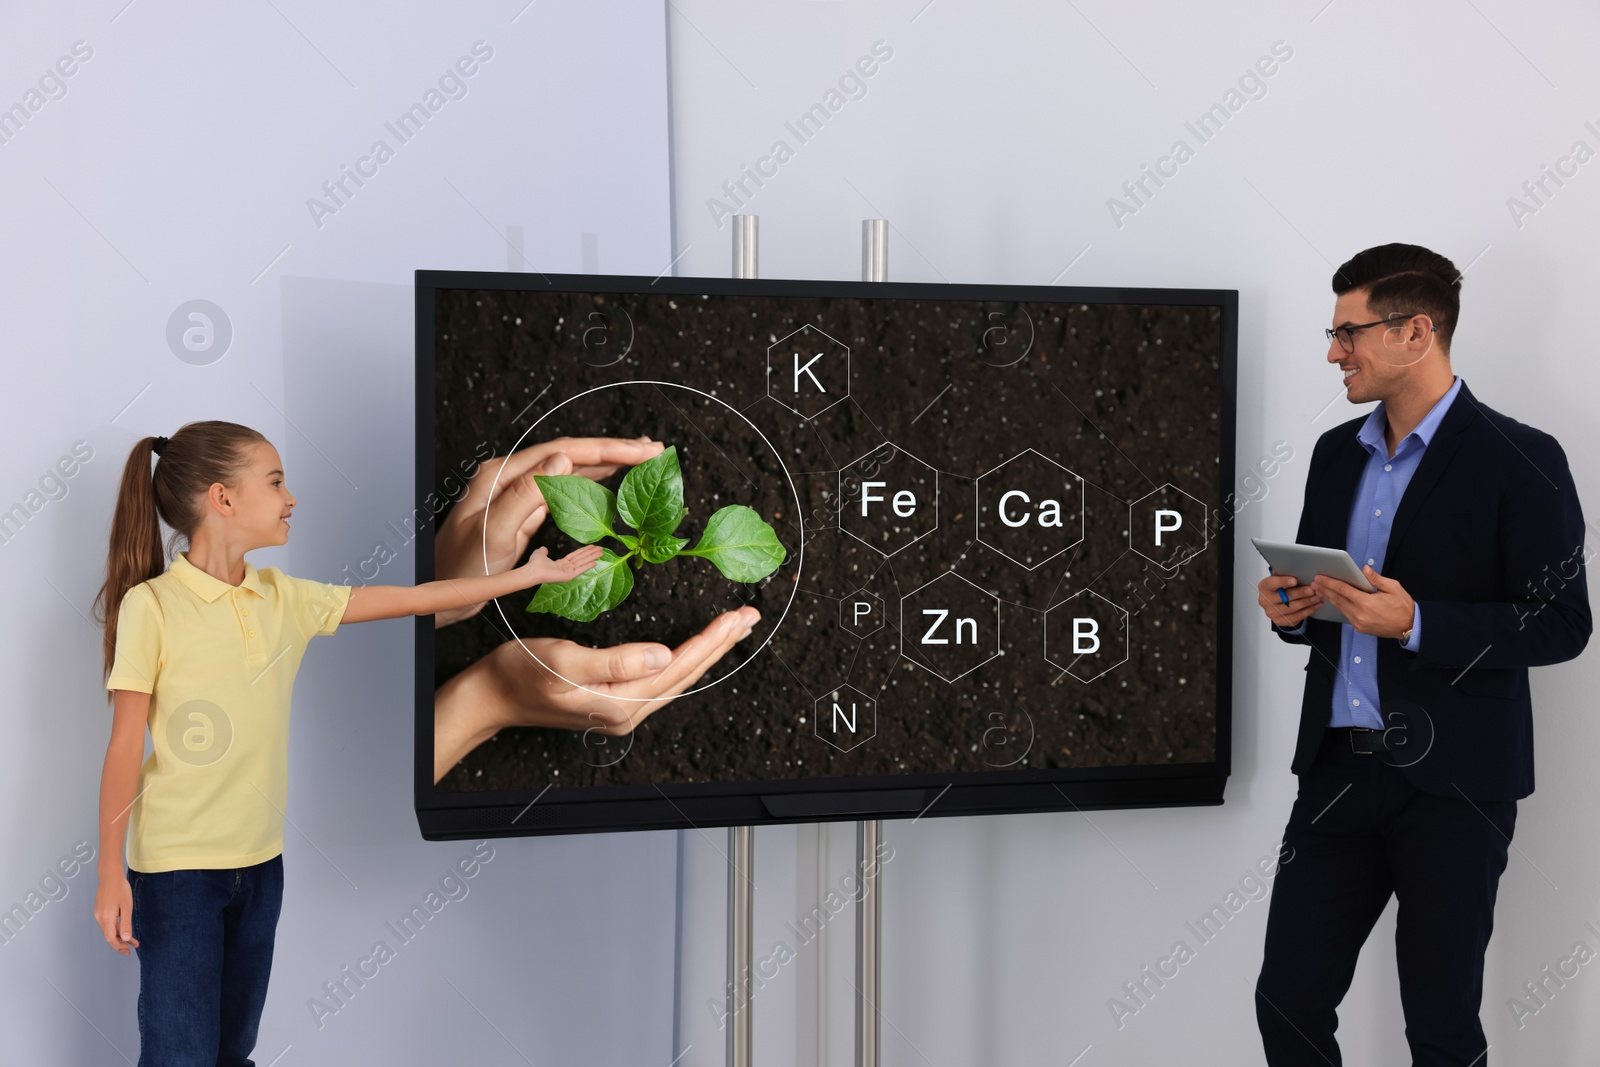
[{"xmin": 838, "ymin": 443, "xmax": 939, "ymax": 555}]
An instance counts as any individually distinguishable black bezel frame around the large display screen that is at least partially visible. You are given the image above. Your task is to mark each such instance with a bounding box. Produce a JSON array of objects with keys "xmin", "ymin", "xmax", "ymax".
[{"xmin": 413, "ymin": 270, "xmax": 1238, "ymax": 841}]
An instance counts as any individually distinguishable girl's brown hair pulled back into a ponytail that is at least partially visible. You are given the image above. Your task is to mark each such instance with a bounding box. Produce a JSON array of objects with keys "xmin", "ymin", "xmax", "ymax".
[{"xmin": 94, "ymin": 421, "xmax": 267, "ymax": 687}]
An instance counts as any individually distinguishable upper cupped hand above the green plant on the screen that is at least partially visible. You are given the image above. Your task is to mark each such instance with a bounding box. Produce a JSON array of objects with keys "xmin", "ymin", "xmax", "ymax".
[{"xmin": 434, "ymin": 437, "xmax": 664, "ymax": 627}]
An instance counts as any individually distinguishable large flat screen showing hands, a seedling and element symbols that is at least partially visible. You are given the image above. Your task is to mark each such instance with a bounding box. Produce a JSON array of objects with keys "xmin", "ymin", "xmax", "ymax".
[{"xmin": 414, "ymin": 270, "xmax": 1237, "ymax": 838}]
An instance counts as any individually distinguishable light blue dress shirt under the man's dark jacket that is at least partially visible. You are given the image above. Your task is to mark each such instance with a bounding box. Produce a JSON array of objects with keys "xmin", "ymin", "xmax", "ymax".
[{"xmin": 1291, "ymin": 378, "xmax": 1461, "ymax": 729}]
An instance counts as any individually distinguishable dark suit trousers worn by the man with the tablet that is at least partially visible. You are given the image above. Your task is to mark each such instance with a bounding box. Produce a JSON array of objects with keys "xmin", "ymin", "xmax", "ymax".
[{"xmin": 1256, "ymin": 731, "xmax": 1517, "ymax": 1067}]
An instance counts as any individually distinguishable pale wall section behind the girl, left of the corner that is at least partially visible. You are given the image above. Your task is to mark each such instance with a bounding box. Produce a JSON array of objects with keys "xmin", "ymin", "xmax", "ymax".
[{"xmin": 0, "ymin": 0, "xmax": 677, "ymax": 1067}]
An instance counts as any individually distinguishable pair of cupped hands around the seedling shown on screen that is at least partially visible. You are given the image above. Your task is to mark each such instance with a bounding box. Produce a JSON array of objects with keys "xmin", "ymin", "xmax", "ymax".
[{"xmin": 434, "ymin": 437, "xmax": 760, "ymax": 782}]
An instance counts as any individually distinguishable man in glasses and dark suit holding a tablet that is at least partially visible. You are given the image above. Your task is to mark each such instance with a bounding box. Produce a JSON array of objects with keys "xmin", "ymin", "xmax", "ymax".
[{"xmin": 1256, "ymin": 245, "xmax": 1592, "ymax": 1067}]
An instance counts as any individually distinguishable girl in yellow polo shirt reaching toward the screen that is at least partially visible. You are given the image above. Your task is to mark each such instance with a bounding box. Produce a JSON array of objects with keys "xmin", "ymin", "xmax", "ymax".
[{"xmin": 94, "ymin": 422, "xmax": 600, "ymax": 1067}]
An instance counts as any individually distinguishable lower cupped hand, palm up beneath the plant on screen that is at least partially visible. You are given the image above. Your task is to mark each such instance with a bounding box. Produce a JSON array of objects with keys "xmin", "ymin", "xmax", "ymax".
[{"xmin": 434, "ymin": 606, "xmax": 762, "ymax": 782}]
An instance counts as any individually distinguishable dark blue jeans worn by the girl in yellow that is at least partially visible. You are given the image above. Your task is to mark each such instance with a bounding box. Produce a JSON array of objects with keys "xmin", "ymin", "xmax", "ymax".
[{"xmin": 128, "ymin": 854, "xmax": 283, "ymax": 1067}]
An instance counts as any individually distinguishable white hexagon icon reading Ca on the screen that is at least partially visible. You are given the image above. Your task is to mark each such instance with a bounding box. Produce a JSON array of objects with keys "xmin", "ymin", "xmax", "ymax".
[{"xmin": 978, "ymin": 448, "xmax": 1083, "ymax": 571}]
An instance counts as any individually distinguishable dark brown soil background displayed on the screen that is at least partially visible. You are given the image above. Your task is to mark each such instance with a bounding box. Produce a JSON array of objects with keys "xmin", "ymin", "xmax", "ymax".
[{"xmin": 435, "ymin": 291, "xmax": 1221, "ymax": 792}]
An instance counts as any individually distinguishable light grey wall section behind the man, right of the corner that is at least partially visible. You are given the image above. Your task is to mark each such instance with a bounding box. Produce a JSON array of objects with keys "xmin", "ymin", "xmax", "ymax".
[{"xmin": 670, "ymin": 0, "xmax": 1600, "ymax": 1067}]
